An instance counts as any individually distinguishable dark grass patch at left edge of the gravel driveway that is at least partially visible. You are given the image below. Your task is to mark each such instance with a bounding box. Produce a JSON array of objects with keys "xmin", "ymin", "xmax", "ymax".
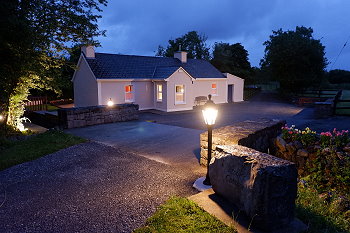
[{"xmin": 0, "ymin": 130, "xmax": 86, "ymax": 170}]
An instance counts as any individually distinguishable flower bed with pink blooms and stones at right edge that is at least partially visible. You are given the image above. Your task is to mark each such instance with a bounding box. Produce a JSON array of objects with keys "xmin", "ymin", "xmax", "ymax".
[{"xmin": 275, "ymin": 125, "xmax": 350, "ymax": 193}]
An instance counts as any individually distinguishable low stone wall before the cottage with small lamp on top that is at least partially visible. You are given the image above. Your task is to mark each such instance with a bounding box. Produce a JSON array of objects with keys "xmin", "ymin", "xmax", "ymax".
[{"xmin": 58, "ymin": 104, "xmax": 139, "ymax": 129}]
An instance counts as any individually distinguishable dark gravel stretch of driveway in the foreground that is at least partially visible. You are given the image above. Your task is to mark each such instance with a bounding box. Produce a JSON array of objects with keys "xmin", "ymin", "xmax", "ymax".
[{"xmin": 0, "ymin": 142, "xmax": 203, "ymax": 232}]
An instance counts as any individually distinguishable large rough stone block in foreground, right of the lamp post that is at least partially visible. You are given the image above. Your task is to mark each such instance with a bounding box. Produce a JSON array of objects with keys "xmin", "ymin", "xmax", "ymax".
[{"xmin": 209, "ymin": 145, "xmax": 297, "ymax": 231}]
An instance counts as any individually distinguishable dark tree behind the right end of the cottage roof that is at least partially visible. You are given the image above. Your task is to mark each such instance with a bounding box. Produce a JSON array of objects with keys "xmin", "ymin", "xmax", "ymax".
[{"xmin": 211, "ymin": 42, "xmax": 252, "ymax": 79}]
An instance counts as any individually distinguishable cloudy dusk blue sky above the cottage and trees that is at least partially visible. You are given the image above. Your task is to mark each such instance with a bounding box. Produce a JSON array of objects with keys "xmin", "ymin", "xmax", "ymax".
[{"xmin": 96, "ymin": 0, "xmax": 350, "ymax": 70}]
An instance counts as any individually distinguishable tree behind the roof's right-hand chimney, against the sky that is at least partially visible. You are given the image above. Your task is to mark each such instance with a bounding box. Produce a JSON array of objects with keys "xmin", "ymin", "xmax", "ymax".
[{"xmin": 156, "ymin": 31, "xmax": 210, "ymax": 60}]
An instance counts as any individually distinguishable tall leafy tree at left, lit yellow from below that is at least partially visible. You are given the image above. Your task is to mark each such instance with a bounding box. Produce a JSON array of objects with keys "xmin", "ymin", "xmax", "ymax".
[{"xmin": 0, "ymin": 0, "xmax": 107, "ymax": 126}]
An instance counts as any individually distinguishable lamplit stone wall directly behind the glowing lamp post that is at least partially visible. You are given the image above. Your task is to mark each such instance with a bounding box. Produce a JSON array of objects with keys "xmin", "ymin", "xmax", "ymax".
[{"xmin": 200, "ymin": 119, "xmax": 286, "ymax": 166}]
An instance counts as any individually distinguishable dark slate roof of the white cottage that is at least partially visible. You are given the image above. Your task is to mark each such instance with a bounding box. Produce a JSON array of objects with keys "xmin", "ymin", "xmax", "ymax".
[{"xmin": 86, "ymin": 53, "xmax": 226, "ymax": 79}]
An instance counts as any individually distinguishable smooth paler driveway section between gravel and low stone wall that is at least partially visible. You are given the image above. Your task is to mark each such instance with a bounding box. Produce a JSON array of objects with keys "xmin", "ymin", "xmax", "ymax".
[{"xmin": 65, "ymin": 121, "xmax": 204, "ymax": 169}]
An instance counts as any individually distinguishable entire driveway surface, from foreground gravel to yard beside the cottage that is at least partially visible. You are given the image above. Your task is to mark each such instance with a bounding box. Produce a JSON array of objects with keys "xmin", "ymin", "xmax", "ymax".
[{"xmin": 0, "ymin": 94, "xmax": 350, "ymax": 233}]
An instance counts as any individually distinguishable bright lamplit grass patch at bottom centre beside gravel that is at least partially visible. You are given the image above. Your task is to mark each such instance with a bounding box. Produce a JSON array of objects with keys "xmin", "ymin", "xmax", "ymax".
[{"xmin": 134, "ymin": 197, "xmax": 237, "ymax": 233}]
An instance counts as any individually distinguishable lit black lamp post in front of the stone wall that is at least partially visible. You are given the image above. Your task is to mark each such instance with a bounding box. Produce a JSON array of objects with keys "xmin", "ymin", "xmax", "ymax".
[{"xmin": 202, "ymin": 95, "xmax": 218, "ymax": 185}]
